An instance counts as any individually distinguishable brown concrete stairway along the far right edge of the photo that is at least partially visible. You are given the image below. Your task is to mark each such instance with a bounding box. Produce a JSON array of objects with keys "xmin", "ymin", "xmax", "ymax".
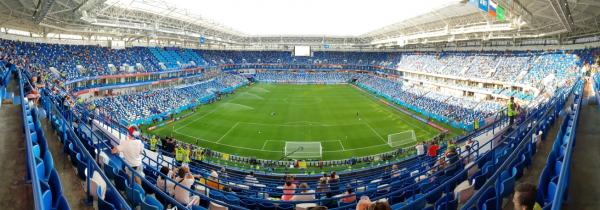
[{"xmin": 562, "ymin": 78, "xmax": 600, "ymax": 210}]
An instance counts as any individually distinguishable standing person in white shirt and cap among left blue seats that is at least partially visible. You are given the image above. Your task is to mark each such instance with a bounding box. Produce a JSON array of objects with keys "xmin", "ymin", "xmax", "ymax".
[{"xmin": 112, "ymin": 129, "xmax": 144, "ymax": 185}]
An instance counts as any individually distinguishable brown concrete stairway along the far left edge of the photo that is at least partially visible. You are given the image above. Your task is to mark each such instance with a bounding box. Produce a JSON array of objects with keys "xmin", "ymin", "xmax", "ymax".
[{"xmin": 0, "ymin": 72, "xmax": 33, "ymax": 209}]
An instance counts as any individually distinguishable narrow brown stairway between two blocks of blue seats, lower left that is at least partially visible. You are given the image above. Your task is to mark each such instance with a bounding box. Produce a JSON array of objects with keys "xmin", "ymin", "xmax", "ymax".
[{"xmin": 42, "ymin": 115, "xmax": 94, "ymax": 210}]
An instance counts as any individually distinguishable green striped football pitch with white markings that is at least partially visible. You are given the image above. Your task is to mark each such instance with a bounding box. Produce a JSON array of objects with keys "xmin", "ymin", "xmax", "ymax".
[{"xmin": 151, "ymin": 83, "xmax": 440, "ymax": 160}]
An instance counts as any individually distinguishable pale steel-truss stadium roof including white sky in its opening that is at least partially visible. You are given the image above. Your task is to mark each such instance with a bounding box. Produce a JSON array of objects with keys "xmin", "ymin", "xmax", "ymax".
[{"xmin": 0, "ymin": 0, "xmax": 600, "ymax": 50}]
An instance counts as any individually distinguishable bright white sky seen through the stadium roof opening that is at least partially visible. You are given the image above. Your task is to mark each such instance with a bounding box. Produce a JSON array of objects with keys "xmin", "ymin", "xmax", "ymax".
[{"xmin": 113, "ymin": 0, "xmax": 458, "ymax": 36}]
